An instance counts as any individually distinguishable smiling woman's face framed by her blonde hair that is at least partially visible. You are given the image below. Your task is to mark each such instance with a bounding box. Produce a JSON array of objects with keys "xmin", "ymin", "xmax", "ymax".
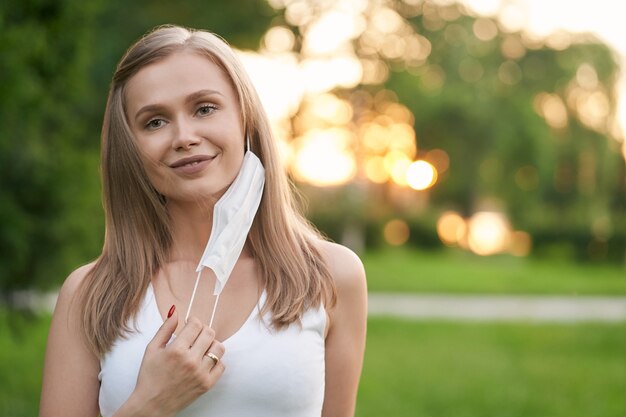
[{"xmin": 125, "ymin": 51, "xmax": 244, "ymax": 203}]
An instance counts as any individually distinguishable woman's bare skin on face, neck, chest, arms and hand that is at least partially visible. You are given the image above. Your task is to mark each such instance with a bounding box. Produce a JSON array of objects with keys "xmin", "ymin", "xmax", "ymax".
[{"xmin": 40, "ymin": 52, "xmax": 367, "ymax": 417}]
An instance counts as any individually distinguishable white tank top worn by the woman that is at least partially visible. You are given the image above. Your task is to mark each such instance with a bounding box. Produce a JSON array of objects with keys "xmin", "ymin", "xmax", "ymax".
[{"xmin": 98, "ymin": 285, "xmax": 326, "ymax": 417}]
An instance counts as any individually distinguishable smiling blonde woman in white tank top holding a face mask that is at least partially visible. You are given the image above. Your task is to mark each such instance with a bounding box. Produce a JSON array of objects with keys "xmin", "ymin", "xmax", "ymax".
[{"xmin": 40, "ymin": 26, "xmax": 366, "ymax": 417}]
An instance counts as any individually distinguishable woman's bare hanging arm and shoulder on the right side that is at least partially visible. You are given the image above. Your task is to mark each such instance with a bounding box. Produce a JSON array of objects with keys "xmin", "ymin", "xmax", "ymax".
[{"xmin": 322, "ymin": 243, "xmax": 367, "ymax": 417}]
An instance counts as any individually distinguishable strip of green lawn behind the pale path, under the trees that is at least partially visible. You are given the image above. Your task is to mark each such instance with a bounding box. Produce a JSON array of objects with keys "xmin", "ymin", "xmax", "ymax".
[{"xmin": 362, "ymin": 249, "xmax": 626, "ymax": 295}]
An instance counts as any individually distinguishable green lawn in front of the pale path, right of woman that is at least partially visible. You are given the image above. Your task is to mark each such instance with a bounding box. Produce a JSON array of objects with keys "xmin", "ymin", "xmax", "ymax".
[{"xmin": 357, "ymin": 318, "xmax": 626, "ymax": 417}]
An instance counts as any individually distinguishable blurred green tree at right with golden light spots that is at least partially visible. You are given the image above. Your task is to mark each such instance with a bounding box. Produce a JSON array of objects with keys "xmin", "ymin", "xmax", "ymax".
[{"xmin": 386, "ymin": 3, "xmax": 625, "ymax": 259}]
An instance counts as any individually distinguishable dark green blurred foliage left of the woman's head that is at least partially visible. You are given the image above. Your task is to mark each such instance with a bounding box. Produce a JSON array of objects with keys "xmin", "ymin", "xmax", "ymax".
[{"xmin": 0, "ymin": 0, "xmax": 101, "ymax": 295}]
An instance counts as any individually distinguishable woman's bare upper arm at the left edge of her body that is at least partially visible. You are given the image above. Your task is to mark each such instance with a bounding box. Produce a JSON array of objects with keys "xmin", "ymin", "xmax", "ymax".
[{"xmin": 39, "ymin": 265, "xmax": 100, "ymax": 417}]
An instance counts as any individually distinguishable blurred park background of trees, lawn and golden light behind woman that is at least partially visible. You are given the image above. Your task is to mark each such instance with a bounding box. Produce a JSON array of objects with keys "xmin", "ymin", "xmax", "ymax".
[{"xmin": 0, "ymin": 0, "xmax": 626, "ymax": 417}]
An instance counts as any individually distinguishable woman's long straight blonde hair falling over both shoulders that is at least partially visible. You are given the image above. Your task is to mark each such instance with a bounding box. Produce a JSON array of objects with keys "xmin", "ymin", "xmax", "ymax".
[{"xmin": 80, "ymin": 26, "xmax": 336, "ymax": 355}]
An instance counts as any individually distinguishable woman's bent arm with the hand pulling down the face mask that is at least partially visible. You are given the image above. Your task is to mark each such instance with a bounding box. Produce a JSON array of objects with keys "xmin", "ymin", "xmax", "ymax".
[{"xmin": 39, "ymin": 267, "xmax": 224, "ymax": 417}]
